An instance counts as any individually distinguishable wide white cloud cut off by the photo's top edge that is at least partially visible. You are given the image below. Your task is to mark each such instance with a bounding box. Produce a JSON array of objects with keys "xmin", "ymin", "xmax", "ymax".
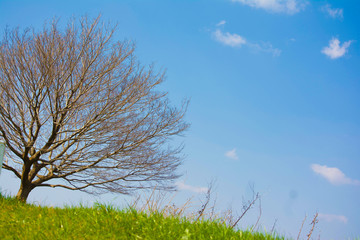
[{"xmin": 232, "ymin": 0, "xmax": 307, "ymax": 14}]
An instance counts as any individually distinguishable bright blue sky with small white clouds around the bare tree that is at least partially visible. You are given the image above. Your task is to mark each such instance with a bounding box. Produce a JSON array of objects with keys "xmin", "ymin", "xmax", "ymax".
[{"xmin": 0, "ymin": 0, "xmax": 360, "ymax": 239}]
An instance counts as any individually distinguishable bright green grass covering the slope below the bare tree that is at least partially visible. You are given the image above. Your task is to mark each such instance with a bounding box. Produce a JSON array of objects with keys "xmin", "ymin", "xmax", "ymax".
[{"xmin": 0, "ymin": 195, "xmax": 284, "ymax": 240}]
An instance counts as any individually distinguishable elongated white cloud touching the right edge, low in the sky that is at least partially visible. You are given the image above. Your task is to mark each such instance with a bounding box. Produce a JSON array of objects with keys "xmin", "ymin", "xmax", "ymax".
[{"xmin": 311, "ymin": 164, "xmax": 360, "ymax": 186}]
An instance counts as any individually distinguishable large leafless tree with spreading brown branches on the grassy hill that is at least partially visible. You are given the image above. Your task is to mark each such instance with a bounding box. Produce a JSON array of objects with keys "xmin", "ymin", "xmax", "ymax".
[{"xmin": 0, "ymin": 17, "xmax": 188, "ymax": 201}]
